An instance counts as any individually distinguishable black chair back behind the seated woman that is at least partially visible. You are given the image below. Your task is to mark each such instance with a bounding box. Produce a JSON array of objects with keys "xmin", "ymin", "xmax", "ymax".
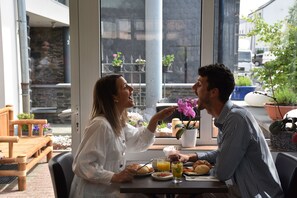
[{"xmin": 48, "ymin": 152, "xmax": 74, "ymax": 198}]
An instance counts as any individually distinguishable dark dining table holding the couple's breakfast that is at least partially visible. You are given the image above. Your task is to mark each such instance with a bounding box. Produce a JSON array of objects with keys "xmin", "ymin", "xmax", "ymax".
[{"xmin": 120, "ymin": 171, "xmax": 228, "ymax": 194}]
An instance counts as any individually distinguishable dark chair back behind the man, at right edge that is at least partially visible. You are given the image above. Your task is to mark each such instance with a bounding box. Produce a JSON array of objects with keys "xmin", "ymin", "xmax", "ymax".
[{"xmin": 275, "ymin": 153, "xmax": 297, "ymax": 198}]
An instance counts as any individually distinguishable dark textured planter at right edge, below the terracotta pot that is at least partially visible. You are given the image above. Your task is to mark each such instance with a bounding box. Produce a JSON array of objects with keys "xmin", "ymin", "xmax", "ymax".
[{"xmin": 270, "ymin": 131, "xmax": 297, "ymax": 151}]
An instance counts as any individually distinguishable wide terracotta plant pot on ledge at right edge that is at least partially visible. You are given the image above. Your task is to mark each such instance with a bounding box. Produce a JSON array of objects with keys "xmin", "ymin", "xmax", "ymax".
[{"xmin": 264, "ymin": 103, "xmax": 297, "ymax": 120}]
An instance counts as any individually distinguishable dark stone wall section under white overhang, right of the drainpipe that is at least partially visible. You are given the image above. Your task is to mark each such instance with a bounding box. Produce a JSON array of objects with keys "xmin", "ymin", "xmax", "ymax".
[{"xmin": 30, "ymin": 28, "xmax": 65, "ymax": 84}]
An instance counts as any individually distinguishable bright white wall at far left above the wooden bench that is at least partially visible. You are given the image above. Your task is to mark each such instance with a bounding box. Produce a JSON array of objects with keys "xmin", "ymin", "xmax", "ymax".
[{"xmin": 0, "ymin": 0, "xmax": 22, "ymax": 115}]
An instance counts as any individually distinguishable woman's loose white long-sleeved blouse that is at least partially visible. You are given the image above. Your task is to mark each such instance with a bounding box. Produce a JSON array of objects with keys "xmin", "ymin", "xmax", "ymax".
[{"xmin": 70, "ymin": 116, "xmax": 154, "ymax": 198}]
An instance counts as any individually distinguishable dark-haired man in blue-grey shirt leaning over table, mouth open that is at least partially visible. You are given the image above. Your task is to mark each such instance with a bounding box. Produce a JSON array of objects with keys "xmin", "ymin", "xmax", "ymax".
[{"xmin": 170, "ymin": 64, "xmax": 284, "ymax": 198}]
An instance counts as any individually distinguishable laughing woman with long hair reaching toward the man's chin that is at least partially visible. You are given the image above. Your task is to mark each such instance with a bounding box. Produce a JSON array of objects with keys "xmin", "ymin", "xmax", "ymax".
[{"xmin": 70, "ymin": 75, "xmax": 175, "ymax": 198}]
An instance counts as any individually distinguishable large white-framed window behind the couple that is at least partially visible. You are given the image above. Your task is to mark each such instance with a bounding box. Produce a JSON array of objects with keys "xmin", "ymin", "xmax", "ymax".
[{"xmin": 72, "ymin": 0, "xmax": 238, "ymax": 150}]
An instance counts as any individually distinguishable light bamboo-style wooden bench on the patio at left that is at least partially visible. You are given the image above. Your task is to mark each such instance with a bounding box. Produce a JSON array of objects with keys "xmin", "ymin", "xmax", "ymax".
[{"xmin": 0, "ymin": 105, "xmax": 53, "ymax": 191}]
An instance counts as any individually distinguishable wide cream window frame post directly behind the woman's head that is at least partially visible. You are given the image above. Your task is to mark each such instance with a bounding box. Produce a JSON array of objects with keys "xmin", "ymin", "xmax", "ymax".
[{"xmin": 69, "ymin": 0, "xmax": 101, "ymax": 153}]
